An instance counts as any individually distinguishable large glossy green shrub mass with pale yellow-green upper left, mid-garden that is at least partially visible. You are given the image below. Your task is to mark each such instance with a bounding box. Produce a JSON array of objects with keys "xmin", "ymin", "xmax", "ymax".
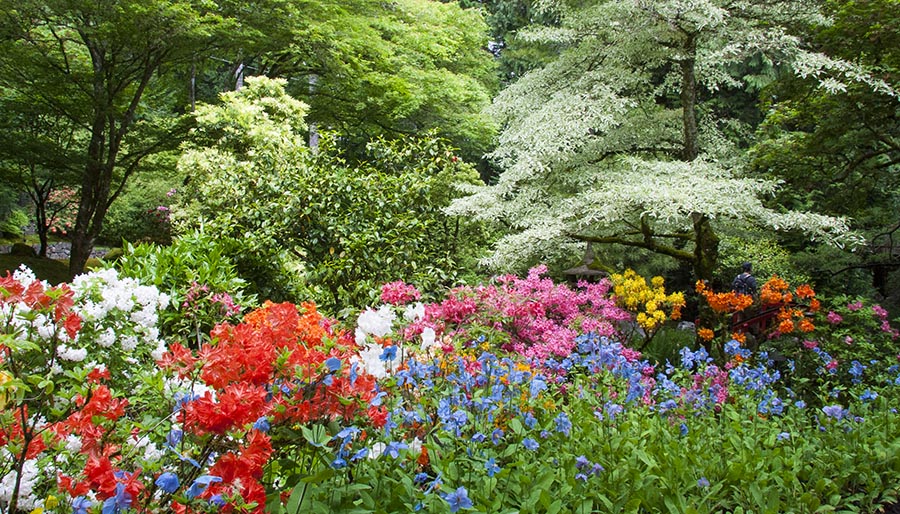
[{"xmin": 173, "ymin": 77, "xmax": 484, "ymax": 308}]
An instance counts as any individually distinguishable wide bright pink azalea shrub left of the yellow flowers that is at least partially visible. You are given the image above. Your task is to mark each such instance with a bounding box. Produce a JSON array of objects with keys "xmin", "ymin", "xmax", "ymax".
[{"xmin": 405, "ymin": 265, "xmax": 631, "ymax": 359}]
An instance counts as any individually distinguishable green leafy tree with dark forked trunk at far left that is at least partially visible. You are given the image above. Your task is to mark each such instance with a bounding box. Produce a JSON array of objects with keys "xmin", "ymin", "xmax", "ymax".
[{"xmin": 0, "ymin": 0, "xmax": 238, "ymax": 276}]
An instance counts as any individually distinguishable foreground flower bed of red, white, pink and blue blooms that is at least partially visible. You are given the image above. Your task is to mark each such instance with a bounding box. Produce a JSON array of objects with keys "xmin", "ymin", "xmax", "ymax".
[{"xmin": 0, "ymin": 268, "xmax": 900, "ymax": 514}]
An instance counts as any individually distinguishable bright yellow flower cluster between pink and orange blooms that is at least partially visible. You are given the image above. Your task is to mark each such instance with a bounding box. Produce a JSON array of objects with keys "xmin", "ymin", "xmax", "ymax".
[{"xmin": 610, "ymin": 269, "xmax": 684, "ymax": 332}]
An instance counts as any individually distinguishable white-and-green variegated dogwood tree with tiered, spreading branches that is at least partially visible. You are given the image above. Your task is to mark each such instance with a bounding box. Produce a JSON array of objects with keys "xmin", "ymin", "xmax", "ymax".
[{"xmin": 450, "ymin": 0, "xmax": 893, "ymax": 279}]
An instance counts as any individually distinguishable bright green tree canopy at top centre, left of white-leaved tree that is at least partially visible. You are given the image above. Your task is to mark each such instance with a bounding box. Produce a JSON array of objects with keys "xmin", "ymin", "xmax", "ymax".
[{"xmin": 259, "ymin": 0, "xmax": 497, "ymax": 159}]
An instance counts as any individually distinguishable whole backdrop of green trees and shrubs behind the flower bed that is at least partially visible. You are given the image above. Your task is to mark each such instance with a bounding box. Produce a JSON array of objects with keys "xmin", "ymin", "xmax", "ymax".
[{"xmin": 0, "ymin": 0, "xmax": 900, "ymax": 320}]
